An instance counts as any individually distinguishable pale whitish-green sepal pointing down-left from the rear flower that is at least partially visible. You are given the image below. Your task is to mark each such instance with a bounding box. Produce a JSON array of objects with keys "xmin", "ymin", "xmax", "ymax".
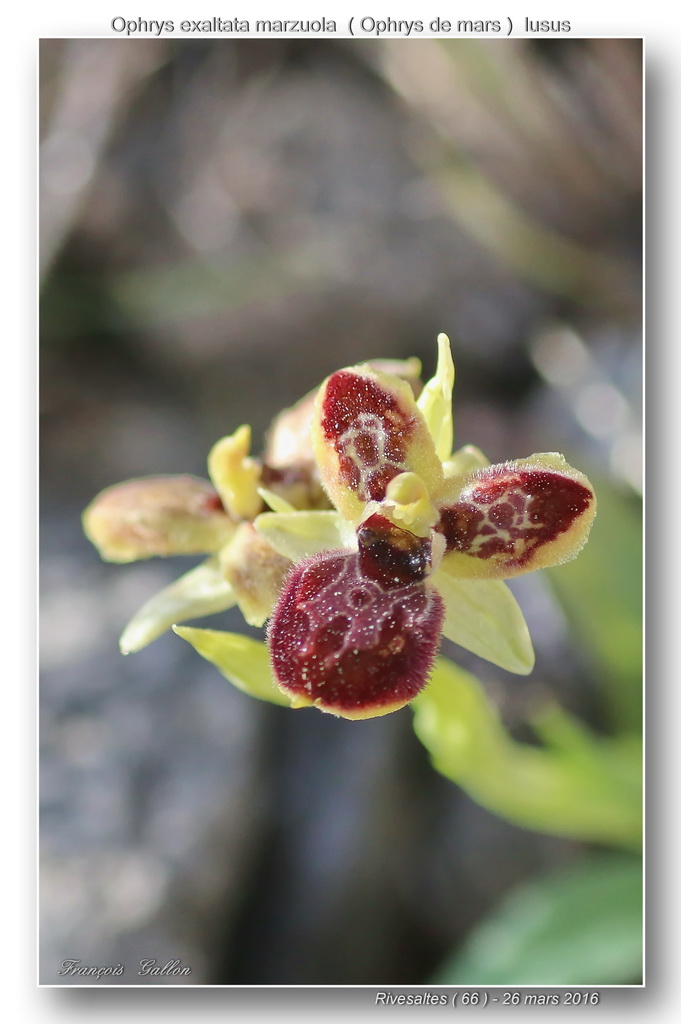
[{"xmin": 120, "ymin": 558, "xmax": 236, "ymax": 654}]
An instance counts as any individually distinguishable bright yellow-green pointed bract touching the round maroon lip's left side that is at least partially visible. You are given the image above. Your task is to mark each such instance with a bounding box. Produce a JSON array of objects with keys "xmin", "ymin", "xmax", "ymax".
[{"xmin": 173, "ymin": 626, "xmax": 291, "ymax": 708}]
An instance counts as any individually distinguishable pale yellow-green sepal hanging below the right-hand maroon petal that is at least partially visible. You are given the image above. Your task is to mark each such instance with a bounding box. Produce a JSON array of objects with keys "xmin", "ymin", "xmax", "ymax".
[{"xmin": 430, "ymin": 566, "xmax": 535, "ymax": 676}]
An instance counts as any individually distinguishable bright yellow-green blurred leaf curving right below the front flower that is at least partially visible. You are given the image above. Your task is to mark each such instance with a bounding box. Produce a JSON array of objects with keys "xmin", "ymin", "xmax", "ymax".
[{"xmin": 412, "ymin": 658, "xmax": 642, "ymax": 849}]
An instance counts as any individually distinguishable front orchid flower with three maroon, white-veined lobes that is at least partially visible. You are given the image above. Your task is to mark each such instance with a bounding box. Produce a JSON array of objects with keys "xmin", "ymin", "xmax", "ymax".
[{"xmin": 249, "ymin": 335, "xmax": 596, "ymax": 719}]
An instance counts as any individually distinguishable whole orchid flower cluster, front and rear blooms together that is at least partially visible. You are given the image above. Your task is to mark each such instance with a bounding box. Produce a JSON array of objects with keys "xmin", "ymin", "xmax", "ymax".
[{"xmin": 84, "ymin": 335, "xmax": 596, "ymax": 719}]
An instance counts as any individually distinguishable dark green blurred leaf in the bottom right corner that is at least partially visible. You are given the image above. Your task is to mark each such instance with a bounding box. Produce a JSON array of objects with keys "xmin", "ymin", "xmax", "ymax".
[{"xmin": 433, "ymin": 854, "xmax": 643, "ymax": 985}]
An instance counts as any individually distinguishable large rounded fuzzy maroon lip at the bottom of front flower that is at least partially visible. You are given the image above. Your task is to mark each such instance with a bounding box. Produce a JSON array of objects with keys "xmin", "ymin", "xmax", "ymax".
[{"xmin": 268, "ymin": 551, "xmax": 444, "ymax": 714}]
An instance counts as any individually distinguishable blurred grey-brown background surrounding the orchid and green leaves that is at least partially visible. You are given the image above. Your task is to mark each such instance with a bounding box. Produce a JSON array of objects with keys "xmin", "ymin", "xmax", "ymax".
[{"xmin": 40, "ymin": 39, "xmax": 641, "ymax": 985}]
